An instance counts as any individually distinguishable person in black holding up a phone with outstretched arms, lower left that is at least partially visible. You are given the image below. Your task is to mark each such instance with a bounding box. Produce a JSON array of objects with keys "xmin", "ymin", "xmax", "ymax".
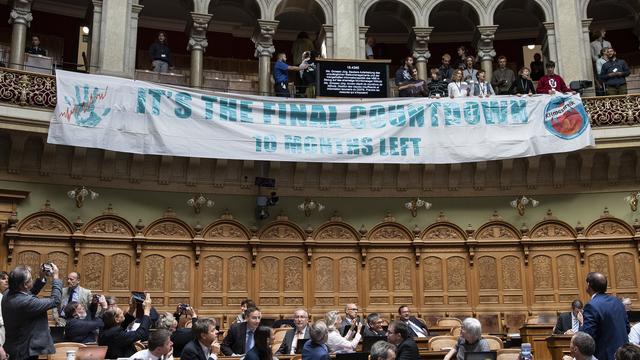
[{"xmin": 98, "ymin": 294, "xmax": 151, "ymax": 359}]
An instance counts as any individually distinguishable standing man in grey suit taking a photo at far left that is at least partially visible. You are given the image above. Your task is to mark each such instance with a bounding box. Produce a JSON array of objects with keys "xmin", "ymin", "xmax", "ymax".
[{"xmin": 2, "ymin": 264, "xmax": 62, "ymax": 359}]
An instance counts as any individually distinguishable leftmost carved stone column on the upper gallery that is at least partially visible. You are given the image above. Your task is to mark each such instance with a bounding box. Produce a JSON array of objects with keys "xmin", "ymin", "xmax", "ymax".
[{"xmin": 9, "ymin": 0, "xmax": 33, "ymax": 70}]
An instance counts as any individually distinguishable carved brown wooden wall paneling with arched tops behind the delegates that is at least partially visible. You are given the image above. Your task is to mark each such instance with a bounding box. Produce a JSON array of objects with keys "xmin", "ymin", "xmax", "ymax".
[{"xmin": 3, "ymin": 206, "xmax": 640, "ymax": 332}]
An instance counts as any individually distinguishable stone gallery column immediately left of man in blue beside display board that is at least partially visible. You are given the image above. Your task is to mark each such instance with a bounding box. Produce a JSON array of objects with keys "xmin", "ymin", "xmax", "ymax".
[{"xmin": 253, "ymin": 20, "xmax": 280, "ymax": 96}]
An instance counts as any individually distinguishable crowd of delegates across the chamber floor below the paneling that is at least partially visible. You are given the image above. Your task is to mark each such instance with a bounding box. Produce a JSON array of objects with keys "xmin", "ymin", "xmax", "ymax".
[{"xmin": 0, "ymin": 262, "xmax": 640, "ymax": 360}]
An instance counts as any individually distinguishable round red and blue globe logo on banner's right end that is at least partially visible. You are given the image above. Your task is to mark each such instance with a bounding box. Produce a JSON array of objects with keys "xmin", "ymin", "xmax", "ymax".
[{"xmin": 544, "ymin": 96, "xmax": 589, "ymax": 140}]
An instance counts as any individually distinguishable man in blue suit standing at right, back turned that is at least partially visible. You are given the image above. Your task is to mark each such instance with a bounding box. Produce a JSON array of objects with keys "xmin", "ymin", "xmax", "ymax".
[{"xmin": 578, "ymin": 272, "xmax": 629, "ymax": 360}]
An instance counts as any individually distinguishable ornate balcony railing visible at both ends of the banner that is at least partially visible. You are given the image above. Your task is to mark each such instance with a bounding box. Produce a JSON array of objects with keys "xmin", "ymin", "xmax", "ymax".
[{"xmin": 0, "ymin": 68, "xmax": 640, "ymax": 128}]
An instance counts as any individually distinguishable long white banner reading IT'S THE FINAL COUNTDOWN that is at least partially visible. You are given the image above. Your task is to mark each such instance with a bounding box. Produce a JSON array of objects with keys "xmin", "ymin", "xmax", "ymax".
[{"xmin": 48, "ymin": 71, "xmax": 594, "ymax": 164}]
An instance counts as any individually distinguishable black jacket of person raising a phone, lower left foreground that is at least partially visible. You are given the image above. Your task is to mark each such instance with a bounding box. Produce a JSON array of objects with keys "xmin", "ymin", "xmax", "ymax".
[{"xmin": 98, "ymin": 314, "xmax": 151, "ymax": 359}]
